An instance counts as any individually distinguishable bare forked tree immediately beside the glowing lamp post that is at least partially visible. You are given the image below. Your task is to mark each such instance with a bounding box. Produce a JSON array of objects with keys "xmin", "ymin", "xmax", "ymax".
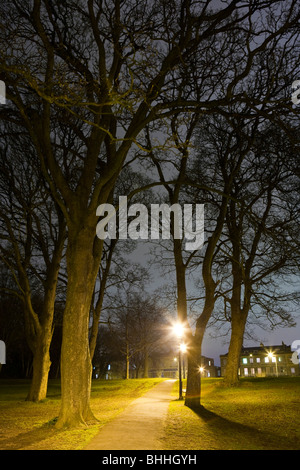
[{"xmin": 147, "ymin": 110, "xmax": 259, "ymax": 408}]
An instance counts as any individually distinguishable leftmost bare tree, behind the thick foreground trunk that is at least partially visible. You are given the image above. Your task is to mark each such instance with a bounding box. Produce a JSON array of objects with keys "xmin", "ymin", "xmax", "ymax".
[{"xmin": 0, "ymin": 132, "xmax": 66, "ymax": 401}]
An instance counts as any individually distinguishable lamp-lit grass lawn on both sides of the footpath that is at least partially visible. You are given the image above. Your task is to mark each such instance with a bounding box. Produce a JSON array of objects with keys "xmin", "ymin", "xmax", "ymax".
[{"xmin": 0, "ymin": 377, "xmax": 300, "ymax": 450}]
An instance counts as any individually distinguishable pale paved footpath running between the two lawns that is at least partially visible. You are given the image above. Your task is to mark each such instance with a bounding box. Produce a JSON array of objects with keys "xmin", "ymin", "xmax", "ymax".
[{"xmin": 84, "ymin": 380, "xmax": 174, "ymax": 450}]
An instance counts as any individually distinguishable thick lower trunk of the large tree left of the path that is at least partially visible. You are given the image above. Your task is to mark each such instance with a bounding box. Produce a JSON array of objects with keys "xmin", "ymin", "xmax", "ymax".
[{"xmin": 56, "ymin": 228, "xmax": 98, "ymax": 428}]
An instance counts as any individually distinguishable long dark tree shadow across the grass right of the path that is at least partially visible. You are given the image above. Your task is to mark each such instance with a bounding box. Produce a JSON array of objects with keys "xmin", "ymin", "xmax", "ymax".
[{"xmin": 190, "ymin": 406, "xmax": 299, "ymax": 450}]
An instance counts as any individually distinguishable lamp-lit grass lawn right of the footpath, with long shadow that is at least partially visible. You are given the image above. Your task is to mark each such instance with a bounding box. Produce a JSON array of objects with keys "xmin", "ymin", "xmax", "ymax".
[{"xmin": 165, "ymin": 377, "xmax": 300, "ymax": 450}]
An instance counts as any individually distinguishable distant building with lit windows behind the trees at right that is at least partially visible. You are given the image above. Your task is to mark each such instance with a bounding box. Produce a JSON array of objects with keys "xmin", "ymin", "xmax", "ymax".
[{"xmin": 220, "ymin": 343, "xmax": 300, "ymax": 377}]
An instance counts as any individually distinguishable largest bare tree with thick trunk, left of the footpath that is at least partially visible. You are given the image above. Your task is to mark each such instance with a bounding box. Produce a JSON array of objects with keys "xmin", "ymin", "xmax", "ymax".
[{"xmin": 0, "ymin": 0, "xmax": 299, "ymax": 427}]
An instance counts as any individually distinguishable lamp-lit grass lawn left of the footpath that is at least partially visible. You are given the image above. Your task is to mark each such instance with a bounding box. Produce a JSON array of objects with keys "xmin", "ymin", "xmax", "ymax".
[{"xmin": 0, "ymin": 379, "xmax": 163, "ymax": 450}]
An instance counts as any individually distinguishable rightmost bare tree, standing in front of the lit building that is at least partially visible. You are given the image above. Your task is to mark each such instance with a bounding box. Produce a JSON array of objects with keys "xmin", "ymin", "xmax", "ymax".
[{"xmin": 216, "ymin": 126, "xmax": 299, "ymax": 384}]
